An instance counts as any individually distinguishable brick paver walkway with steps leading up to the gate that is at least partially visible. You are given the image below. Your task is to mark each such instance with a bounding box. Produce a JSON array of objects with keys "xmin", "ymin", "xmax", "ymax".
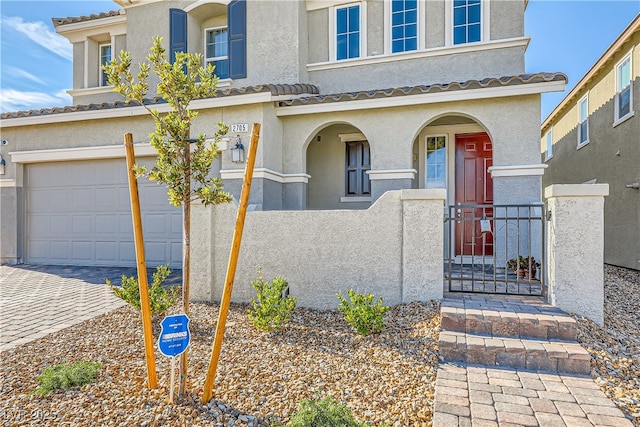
[{"xmin": 433, "ymin": 295, "xmax": 632, "ymax": 427}]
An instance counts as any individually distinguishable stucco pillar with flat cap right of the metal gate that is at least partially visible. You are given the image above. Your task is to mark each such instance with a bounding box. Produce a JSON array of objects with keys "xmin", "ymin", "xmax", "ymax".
[{"xmin": 544, "ymin": 184, "xmax": 609, "ymax": 326}]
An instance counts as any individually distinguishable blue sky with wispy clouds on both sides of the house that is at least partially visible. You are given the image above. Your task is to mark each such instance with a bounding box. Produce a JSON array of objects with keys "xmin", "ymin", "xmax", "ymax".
[{"xmin": 0, "ymin": 0, "xmax": 640, "ymax": 120}]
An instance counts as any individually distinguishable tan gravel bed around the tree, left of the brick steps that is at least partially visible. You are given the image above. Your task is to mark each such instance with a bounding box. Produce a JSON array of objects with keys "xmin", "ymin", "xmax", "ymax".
[{"xmin": 0, "ymin": 302, "xmax": 440, "ymax": 426}]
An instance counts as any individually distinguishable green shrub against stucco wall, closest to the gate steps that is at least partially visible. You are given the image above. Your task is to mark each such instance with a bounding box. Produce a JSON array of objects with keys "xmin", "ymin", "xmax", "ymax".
[{"xmin": 336, "ymin": 289, "xmax": 389, "ymax": 335}]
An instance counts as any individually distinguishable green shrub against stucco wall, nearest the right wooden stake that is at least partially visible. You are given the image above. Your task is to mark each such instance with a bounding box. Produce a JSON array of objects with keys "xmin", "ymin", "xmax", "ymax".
[{"xmin": 248, "ymin": 271, "xmax": 298, "ymax": 332}]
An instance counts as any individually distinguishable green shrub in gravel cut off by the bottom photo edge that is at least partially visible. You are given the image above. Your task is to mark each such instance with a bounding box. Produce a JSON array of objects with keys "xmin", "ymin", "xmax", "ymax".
[{"xmin": 289, "ymin": 396, "xmax": 366, "ymax": 427}]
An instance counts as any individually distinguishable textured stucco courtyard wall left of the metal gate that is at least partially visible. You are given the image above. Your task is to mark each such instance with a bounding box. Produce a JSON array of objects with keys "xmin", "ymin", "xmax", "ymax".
[{"xmin": 191, "ymin": 190, "xmax": 445, "ymax": 309}]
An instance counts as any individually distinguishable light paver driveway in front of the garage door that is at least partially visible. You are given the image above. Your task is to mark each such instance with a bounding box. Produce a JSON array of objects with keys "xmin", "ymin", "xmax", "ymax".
[{"xmin": 0, "ymin": 265, "xmax": 179, "ymax": 351}]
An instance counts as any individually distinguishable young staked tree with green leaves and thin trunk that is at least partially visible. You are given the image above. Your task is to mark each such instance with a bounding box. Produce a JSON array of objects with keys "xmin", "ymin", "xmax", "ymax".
[{"xmin": 104, "ymin": 37, "xmax": 231, "ymax": 394}]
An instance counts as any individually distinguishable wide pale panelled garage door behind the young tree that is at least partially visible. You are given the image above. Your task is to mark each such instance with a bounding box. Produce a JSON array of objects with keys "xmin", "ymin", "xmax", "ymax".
[{"xmin": 24, "ymin": 159, "xmax": 182, "ymax": 268}]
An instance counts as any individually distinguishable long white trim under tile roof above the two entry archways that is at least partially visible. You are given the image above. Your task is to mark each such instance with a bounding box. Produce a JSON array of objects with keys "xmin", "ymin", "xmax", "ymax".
[{"xmin": 276, "ymin": 81, "xmax": 565, "ymax": 117}]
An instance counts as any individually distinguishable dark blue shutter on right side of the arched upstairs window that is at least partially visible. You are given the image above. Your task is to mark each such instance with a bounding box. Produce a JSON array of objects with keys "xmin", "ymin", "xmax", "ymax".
[{"xmin": 227, "ymin": 0, "xmax": 247, "ymax": 79}]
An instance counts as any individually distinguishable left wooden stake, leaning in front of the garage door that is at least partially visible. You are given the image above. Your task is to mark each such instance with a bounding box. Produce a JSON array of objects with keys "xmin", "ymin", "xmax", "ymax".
[{"xmin": 124, "ymin": 133, "xmax": 158, "ymax": 389}]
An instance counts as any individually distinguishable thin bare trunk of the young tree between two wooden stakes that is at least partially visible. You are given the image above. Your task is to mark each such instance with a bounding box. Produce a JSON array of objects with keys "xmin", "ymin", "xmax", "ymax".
[{"xmin": 178, "ymin": 141, "xmax": 191, "ymax": 396}]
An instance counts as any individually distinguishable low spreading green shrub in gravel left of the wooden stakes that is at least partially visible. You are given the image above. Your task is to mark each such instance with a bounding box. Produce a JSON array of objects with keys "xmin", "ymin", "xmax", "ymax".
[{"xmin": 33, "ymin": 361, "xmax": 102, "ymax": 396}]
